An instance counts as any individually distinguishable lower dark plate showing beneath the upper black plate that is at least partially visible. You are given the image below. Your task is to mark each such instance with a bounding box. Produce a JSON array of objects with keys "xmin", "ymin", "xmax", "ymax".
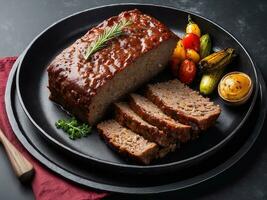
[{"xmin": 5, "ymin": 56, "xmax": 267, "ymax": 194}]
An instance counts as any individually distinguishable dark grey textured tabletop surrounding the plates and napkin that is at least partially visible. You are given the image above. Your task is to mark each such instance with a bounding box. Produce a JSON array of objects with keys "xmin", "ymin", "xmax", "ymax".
[{"xmin": 0, "ymin": 0, "xmax": 267, "ymax": 200}]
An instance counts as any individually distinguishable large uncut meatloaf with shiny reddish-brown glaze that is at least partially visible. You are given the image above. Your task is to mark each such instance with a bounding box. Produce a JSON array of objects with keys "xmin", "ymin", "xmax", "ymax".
[{"xmin": 47, "ymin": 10, "xmax": 178, "ymax": 125}]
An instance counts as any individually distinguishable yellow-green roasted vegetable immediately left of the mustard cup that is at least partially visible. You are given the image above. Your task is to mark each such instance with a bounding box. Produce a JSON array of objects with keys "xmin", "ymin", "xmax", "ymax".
[{"xmin": 199, "ymin": 69, "xmax": 224, "ymax": 95}]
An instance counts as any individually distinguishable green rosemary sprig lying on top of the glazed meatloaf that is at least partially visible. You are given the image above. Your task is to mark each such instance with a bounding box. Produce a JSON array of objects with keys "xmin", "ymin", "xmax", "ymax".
[{"xmin": 84, "ymin": 19, "xmax": 132, "ymax": 60}]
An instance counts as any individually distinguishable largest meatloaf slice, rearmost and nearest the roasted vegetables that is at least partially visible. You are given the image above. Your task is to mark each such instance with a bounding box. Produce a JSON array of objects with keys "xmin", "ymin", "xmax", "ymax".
[{"xmin": 146, "ymin": 79, "xmax": 221, "ymax": 131}]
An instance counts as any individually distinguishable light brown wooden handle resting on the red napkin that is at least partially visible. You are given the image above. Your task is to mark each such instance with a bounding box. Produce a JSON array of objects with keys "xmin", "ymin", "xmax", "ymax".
[{"xmin": 0, "ymin": 129, "xmax": 34, "ymax": 182}]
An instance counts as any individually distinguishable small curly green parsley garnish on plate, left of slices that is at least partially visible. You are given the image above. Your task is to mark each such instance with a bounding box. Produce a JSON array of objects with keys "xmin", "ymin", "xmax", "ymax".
[{"xmin": 56, "ymin": 117, "xmax": 91, "ymax": 140}]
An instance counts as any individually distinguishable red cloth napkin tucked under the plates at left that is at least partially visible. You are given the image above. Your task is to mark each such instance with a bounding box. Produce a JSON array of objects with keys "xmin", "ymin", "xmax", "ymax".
[{"xmin": 0, "ymin": 57, "xmax": 107, "ymax": 200}]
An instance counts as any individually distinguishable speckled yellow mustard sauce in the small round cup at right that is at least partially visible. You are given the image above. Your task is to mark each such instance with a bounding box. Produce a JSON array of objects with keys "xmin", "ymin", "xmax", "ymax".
[{"xmin": 219, "ymin": 72, "xmax": 251, "ymax": 100}]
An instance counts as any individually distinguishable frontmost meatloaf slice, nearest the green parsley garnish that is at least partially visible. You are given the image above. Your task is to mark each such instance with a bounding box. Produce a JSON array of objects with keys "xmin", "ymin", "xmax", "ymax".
[{"xmin": 97, "ymin": 120, "xmax": 159, "ymax": 164}]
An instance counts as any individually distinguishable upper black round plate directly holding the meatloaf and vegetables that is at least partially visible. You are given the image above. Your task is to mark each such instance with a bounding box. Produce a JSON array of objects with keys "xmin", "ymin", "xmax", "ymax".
[{"xmin": 16, "ymin": 5, "xmax": 258, "ymax": 173}]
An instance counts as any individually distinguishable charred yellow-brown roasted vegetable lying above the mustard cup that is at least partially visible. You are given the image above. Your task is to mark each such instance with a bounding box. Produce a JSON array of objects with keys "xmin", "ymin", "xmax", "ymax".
[{"xmin": 199, "ymin": 48, "xmax": 236, "ymax": 72}]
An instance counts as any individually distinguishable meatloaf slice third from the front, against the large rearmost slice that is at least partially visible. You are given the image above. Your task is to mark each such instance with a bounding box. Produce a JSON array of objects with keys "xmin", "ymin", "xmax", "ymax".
[{"xmin": 130, "ymin": 94, "xmax": 191, "ymax": 142}]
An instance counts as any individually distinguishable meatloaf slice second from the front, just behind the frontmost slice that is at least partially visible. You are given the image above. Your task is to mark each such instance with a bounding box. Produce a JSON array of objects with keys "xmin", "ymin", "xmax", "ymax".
[{"xmin": 115, "ymin": 102, "xmax": 176, "ymax": 147}]
